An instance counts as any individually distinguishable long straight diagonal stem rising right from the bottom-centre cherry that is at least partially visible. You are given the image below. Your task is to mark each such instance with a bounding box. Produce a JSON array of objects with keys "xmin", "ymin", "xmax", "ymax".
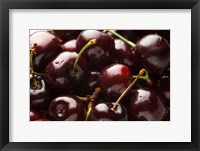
[{"xmin": 111, "ymin": 69, "xmax": 146, "ymax": 111}]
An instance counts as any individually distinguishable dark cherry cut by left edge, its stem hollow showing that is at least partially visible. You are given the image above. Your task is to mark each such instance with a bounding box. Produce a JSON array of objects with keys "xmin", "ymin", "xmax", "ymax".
[{"xmin": 30, "ymin": 74, "xmax": 53, "ymax": 110}]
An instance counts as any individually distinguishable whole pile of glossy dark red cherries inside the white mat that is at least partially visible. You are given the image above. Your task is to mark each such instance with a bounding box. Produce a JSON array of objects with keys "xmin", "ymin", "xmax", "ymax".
[{"xmin": 30, "ymin": 30, "xmax": 170, "ymax": 121}]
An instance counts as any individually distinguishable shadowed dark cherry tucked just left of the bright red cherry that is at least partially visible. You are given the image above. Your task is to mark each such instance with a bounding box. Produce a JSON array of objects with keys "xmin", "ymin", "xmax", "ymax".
[{"xmin": 77, "ymin": 71, "xmax": 99, "ymax": 96}]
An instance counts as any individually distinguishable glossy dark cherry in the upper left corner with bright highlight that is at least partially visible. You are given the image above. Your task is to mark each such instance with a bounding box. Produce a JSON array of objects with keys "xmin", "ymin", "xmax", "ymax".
[{"xmin": 30, "ymin": 31, "xmax": 62, "ymax": 72}]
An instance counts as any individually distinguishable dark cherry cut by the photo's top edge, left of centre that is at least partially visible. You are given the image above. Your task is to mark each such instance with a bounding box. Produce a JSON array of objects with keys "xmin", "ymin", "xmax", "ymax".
[{"xmin": 49, "ymin": 30, "xmax": 81, "ymax": 43}]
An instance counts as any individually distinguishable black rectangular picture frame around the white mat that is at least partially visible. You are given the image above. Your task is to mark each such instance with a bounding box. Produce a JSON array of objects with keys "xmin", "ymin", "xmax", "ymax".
[{"xmin": 0, "ymin": 0, "xmax": 200, "ymax": 151}]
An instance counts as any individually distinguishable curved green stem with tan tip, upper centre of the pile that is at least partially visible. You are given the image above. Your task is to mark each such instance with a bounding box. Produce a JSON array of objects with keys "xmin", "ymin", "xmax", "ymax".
[{"xmin": 71, "ymin": 39, "xmax": 97, "ymax": 75}]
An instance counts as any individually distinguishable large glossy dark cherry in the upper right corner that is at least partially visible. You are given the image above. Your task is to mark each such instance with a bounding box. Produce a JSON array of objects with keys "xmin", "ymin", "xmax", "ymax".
[{"xmin": 136, "ymin": 34, "xmax": 170, "ymax": 74}]
